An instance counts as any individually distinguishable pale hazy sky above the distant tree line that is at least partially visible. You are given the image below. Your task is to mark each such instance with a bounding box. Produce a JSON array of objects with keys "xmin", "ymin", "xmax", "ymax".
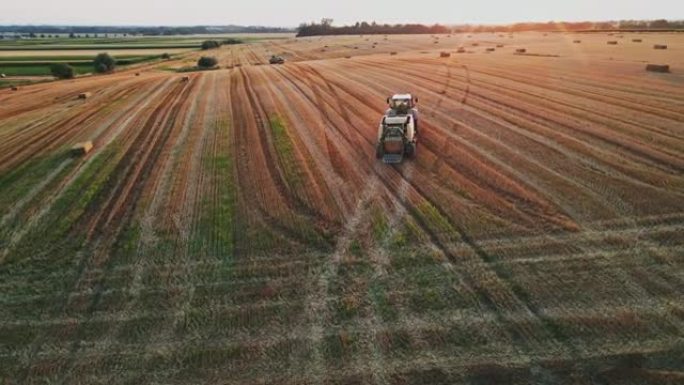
[{"xmin": 0, "ymin": 0, "xmax": 684, "ymax": 27}]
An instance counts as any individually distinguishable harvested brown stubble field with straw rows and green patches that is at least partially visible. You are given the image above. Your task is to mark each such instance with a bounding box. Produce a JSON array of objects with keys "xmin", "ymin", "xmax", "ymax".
[{"xmin": 0, "ymin": 33, "xmax": 684, "ymax": 384}]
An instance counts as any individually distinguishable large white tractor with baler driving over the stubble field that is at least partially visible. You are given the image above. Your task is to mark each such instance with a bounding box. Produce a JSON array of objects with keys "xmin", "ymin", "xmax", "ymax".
[{"xmin": 375, "ymin": 94, "xmax": 418, "ymax": 164}]
